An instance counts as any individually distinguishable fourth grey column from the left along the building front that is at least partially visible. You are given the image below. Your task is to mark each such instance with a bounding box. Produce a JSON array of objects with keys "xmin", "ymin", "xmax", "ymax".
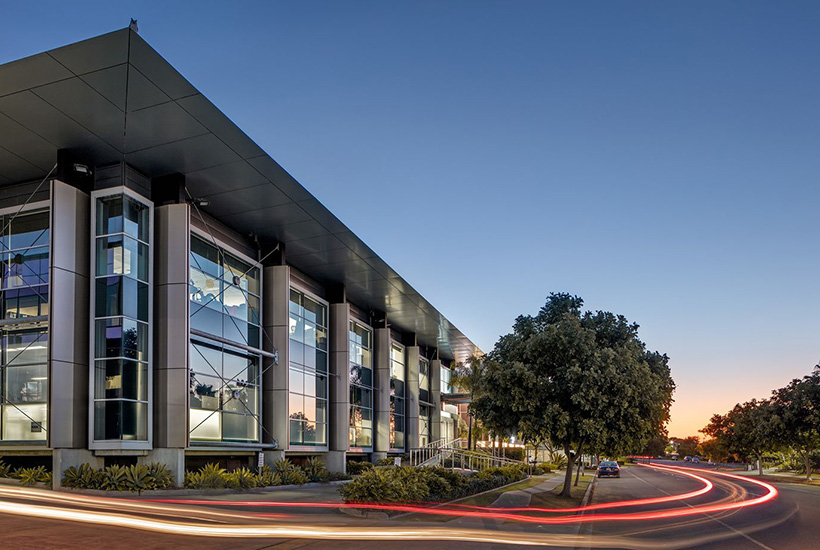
[{"xmin": 327, "ymin": 303, "xmax": 350, "ymax": 472}]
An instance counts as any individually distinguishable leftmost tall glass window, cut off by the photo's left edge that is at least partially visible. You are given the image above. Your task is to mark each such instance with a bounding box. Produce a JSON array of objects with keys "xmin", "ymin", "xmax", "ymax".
[{"xmin": 0, "ymin": 210, "xmax": 49, "ymax": 442}]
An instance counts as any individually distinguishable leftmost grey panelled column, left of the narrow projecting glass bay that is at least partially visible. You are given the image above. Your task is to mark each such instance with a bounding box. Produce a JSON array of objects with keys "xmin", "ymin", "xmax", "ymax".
[{"xmin": 45, "ymin": 180, "xmax": 94, "ymax": 487}]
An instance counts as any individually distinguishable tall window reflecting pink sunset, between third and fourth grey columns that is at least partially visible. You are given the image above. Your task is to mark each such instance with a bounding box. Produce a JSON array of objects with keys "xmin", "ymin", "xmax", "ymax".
[{"xmin": 288, "ymin": 289, "xmax": 328, "ymax": 447}]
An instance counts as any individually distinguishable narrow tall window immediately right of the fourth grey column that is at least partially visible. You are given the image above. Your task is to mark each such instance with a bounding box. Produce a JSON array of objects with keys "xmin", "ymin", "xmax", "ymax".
[{"xmin": 349, "ymin": 321, "xmax": 373, "ymax": 448}]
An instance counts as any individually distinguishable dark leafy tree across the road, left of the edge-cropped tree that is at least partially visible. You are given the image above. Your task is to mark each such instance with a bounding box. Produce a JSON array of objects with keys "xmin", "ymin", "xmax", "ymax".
[{"xmin": 701, "ymin": 399, "xmax": 783, "ymax": 475}]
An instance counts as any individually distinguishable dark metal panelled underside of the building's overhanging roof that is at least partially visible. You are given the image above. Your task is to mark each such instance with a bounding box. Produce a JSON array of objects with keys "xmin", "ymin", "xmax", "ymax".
[{"xmin": 0, "ymin": 29, "xmax": 478, "ymax": 361}]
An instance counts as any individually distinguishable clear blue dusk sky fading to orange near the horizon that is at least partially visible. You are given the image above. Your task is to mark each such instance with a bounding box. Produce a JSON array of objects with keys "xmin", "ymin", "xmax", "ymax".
[{"xmin": 0, "ymin": 0, "xmax": 820, "ymax": 437}]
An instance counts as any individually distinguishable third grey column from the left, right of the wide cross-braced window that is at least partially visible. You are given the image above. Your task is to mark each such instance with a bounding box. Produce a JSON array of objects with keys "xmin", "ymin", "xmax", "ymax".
[{"xmin": 262, "ymin": 265, "xmax": 290, "ymax": 465}]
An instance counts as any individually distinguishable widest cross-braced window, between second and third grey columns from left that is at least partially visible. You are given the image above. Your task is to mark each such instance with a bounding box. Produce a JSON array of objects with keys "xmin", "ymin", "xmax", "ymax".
[{"xmin": 188, "ymin": 235, "xmax": 262, "ymax": 443}]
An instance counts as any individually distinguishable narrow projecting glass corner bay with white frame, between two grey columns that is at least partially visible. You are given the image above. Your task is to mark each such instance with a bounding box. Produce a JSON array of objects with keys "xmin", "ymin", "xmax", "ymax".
[{"xmin": 94, "ymin": 194, "xmax": 151, "ymax": 441}]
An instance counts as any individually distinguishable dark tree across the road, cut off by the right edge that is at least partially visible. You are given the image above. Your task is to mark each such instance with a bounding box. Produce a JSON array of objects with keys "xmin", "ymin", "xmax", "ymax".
[{"xmin": 771, "ymin": 365, "xmax": 820, "ymax": 480}]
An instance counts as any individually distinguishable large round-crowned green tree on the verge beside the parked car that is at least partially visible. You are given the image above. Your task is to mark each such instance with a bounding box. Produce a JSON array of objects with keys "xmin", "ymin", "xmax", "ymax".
[{"xmin": 472, "ymin": 293, "xmax": 675, "ymax": 496}]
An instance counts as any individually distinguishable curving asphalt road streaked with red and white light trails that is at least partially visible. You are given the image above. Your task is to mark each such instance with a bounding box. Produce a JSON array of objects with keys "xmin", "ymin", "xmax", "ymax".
[{"xmin": 0, "ymin": 463, "xmax": 820, "ymax": 550}]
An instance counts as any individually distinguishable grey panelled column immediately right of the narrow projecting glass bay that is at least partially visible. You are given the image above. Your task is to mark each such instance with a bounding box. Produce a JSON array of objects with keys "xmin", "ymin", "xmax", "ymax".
[{"xmin": 150, "ymin": 203, "xmax": 191, "ymax": 486}]
